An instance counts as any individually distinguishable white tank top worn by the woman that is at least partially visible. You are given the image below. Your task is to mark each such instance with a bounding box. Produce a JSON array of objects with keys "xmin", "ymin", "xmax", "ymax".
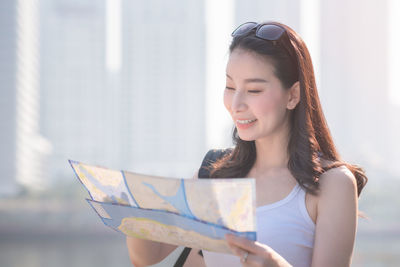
[{"xmin": 203, "ymin": 183, "xmax": 315, "ymax": 267}]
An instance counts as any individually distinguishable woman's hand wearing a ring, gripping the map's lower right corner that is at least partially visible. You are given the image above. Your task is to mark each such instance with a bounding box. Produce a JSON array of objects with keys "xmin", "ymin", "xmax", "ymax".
[{"xmin": 225, "ymin": 234, "xmax": 292, "ymax": 267}]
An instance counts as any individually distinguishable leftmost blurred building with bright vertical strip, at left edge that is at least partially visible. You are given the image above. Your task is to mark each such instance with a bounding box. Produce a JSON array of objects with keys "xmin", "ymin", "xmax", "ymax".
[{"xmin": 0, "ymin": 0, "xmax": 51, "ymax": 194}]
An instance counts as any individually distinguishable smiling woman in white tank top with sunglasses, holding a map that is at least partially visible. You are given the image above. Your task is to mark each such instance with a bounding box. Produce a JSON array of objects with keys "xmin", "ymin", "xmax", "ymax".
[{"xmin": 128, "ymin": 22, "xmax": 367, "ymax": 267}]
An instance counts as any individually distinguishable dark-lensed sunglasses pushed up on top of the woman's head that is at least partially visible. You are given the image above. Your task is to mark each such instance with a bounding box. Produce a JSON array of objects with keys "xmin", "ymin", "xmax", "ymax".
[{"xmin": 231, "ymin": 22, "xmax": 296, "ymax": 63}]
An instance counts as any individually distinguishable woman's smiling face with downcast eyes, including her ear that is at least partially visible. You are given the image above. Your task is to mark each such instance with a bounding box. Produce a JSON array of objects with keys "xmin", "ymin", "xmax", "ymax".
[{"xmin": 224, "ymin": 48, "xmax": 298, "ymax": 141}]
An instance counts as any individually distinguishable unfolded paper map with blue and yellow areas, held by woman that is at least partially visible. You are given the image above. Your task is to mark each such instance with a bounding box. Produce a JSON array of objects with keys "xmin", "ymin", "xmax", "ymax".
[{"xmin": 69, "ymin": 160, "xmax": 256, "ymax": 253}]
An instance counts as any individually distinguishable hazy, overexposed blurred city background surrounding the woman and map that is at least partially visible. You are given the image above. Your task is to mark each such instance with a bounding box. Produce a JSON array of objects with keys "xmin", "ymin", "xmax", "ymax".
[{"xmin": 0, "ymin": 0, "xmax": 400, "ymax": 267}]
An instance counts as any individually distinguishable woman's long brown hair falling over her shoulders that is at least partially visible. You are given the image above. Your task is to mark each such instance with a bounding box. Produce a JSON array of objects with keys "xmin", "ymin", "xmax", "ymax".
[{"xmin": 210, "ymin": 22, "xmax": 368, "ymax": 195}]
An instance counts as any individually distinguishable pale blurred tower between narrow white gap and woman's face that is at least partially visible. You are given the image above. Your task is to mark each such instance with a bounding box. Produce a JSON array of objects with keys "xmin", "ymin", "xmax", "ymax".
[{"xmin": 120, "ymin": 0, "xmax": 206, "ymax": 178}]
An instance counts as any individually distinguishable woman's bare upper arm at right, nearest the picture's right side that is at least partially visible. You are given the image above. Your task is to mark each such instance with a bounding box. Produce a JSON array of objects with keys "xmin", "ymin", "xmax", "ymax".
[{"xmin": 312, "ymin": 167, "xmax": 358, "ymax": 266}]
